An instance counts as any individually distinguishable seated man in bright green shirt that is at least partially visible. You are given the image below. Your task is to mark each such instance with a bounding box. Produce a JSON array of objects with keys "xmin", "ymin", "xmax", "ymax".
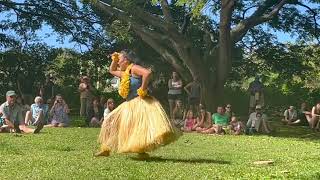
[{"xmin": 201, "ymin": 106, "xmax": 229, "ymax": 134}]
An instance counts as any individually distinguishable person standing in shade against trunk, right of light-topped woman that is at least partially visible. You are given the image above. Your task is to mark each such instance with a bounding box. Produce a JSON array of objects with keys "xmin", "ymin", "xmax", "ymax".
[{"xmin": 184, "ymin": 77, "xmax": 201, "ymax": 113}]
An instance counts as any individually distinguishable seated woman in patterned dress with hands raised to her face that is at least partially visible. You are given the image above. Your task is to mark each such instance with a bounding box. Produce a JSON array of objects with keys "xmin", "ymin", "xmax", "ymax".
[{"xmin": 49, "ymin": 94, "xmax": 70, "ymax": 127}]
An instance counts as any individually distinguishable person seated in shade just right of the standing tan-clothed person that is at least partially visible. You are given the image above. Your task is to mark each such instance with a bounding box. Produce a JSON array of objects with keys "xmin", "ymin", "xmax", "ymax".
[{"xmin": 89, "ymin": 99, "xmax": 104, "ymax": 127}]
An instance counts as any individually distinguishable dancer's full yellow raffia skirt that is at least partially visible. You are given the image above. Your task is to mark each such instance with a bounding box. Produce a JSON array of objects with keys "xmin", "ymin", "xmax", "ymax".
[{"xmin": 98, "ymin": 97, "xmax": 180, "ymax": 153}]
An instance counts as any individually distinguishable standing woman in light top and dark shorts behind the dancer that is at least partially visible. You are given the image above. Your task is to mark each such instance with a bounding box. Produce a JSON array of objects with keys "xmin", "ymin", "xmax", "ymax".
[{"xmin": 168, "ymin": 72, "xmax": 183, "ymax": 119}]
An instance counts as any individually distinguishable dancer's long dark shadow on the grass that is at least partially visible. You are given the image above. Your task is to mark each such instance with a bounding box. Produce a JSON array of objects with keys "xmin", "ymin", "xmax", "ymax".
[{"xmin": 131, "ymin": 156, "xmax": 231, "ymax": 164}]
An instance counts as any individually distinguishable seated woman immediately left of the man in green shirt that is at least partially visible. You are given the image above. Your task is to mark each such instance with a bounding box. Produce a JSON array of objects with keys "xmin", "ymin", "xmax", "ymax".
[{"xmin": 195, "ymin": 104, "xmax": 212, "ymax": 132}]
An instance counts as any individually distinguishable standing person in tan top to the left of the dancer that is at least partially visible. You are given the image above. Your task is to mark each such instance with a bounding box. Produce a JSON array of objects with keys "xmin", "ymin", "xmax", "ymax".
[{"xmin": 79, "ymin": 76, "xmax": 93, "ymax": 125}]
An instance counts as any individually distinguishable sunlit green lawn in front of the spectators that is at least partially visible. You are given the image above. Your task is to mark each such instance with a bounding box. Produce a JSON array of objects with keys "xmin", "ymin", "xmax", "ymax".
[{"xmin": 0, "ymin": 120, "xmax": 320, "ymax": 179}]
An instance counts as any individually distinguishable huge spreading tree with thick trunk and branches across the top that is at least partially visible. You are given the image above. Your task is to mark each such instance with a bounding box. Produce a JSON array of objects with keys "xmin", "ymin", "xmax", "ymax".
[{"xmin": 0, "ymin": 0, "xmax": 319, "ymax": 107}]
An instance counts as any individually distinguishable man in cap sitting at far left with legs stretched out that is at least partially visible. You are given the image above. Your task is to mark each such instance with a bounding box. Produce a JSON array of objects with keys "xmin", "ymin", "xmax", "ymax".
[{"xmin": 0, "ymin": 91, "xmax": 44, "ymax": 133}]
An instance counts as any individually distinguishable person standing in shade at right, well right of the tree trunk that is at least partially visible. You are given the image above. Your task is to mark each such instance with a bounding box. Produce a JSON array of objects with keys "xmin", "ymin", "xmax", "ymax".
[{"xmin": 248, "ymin": 76, "xmax": 264, "ymax": 112}]
